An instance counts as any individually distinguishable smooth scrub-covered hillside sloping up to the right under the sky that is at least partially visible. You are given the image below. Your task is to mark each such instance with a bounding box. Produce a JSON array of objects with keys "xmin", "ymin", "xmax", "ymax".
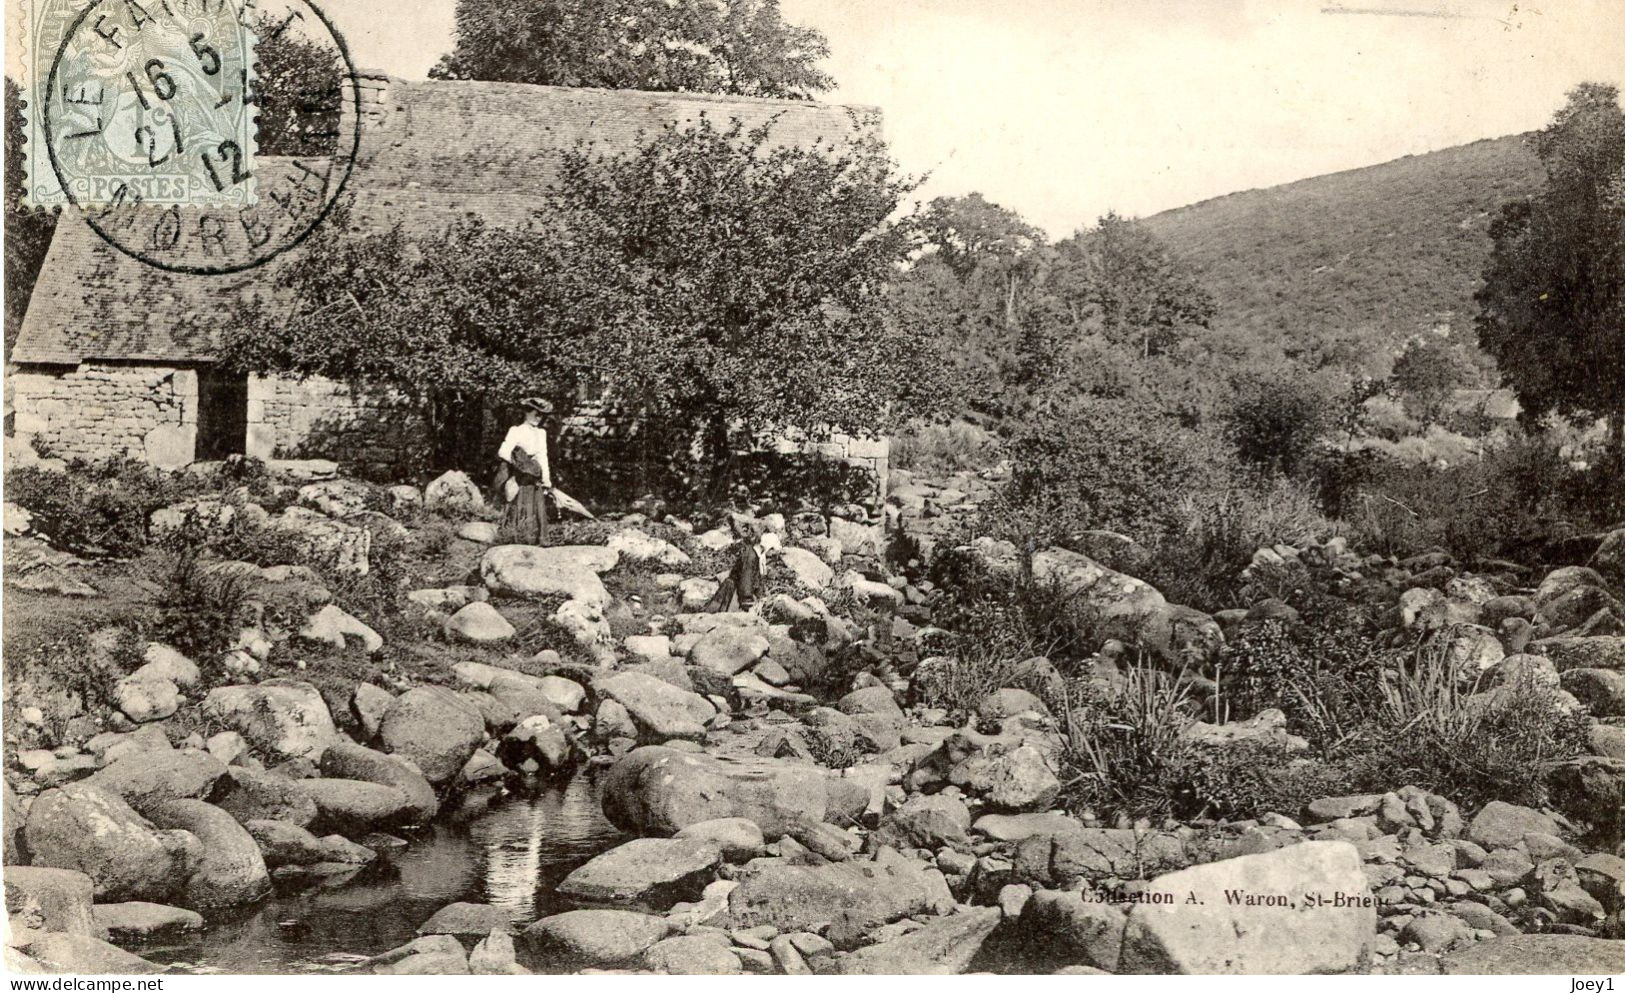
[{"xmin": 1146, "ymin": 135, "xmax": 1544, "ymax": 373}]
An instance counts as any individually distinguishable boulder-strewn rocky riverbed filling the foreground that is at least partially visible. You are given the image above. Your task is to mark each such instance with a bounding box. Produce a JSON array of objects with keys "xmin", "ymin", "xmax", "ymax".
[{"xmin": 5, "ymin": 461, "xmax": 1625, "ymax": 973}]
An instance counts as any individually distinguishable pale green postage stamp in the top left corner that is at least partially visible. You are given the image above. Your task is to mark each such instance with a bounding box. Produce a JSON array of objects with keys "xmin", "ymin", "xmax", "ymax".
[{"xmin": 24, "ymin": 0, "xmax": 257, "ymax": 210}]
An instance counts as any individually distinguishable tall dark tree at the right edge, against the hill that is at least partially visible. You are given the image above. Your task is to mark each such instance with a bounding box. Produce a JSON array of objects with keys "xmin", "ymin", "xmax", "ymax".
[{"xmin": 1477, "ymin": 83, "xmax": 1625, "ymax": 465}]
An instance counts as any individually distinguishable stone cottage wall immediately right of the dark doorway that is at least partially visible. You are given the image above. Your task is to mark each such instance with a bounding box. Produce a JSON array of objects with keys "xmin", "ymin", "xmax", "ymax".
[{"xmin": 247, "ymin": 375, "xmax": 429, "ymax": 478}]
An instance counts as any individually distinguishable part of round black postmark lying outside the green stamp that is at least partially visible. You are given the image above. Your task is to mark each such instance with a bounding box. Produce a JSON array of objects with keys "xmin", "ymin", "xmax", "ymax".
[{"xmin": 41, "ymin": 0, "xmax": 361, "ymax": 275}]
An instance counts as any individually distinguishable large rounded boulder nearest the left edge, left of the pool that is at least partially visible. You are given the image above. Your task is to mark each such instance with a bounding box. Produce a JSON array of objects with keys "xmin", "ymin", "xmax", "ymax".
[{"xmin": 23, "ymin": 783, "xmax": 198, "ymax": 902}]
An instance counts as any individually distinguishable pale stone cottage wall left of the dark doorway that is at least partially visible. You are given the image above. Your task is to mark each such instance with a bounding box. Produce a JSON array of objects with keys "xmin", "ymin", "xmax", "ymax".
[{"xmin": 10, "ymin": 364, "xmax": 198, "ymax": 468}]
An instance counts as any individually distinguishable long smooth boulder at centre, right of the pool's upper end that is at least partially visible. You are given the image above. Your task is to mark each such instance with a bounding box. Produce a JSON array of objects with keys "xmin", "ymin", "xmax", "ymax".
[{"xmin": 603, "ymin": 746, "xmax": 832, "ymax": 837}]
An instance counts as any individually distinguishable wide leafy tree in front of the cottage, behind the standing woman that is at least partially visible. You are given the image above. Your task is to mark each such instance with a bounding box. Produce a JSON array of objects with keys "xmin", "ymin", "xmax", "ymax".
[{"xmin": 224, "ymin": 120, "xmax": 949, "ymax": 479}]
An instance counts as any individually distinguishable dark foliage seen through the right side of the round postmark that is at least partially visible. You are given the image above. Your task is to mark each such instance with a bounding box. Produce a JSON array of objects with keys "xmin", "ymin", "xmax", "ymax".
[{"xmin": 250, "ymin": 10, "xmax": 346, "ymax": 156}]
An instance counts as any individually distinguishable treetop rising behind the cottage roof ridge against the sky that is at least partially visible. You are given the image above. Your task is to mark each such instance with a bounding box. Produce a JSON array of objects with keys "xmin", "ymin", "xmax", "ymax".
[{"xmin": 431, "ymin": 0, "xmax": 835, "ymax": 99}]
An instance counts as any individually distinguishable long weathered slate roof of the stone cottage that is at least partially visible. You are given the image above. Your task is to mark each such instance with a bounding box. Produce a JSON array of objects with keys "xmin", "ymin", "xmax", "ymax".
[{"xmin": 8, "ymin": 76, "xmax": 879, "ymax": 364}]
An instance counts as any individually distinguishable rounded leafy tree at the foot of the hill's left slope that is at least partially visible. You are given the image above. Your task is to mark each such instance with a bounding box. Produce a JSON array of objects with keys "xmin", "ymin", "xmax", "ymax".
[{"xmin": 1055, "ymin": 213, "xmax": 1214, "ymax": 358}]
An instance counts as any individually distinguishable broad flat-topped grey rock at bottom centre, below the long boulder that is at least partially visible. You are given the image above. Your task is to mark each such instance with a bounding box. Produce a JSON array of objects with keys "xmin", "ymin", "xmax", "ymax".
[{"xmin": 728, "ymin": 850, "xmax": 952, "ymax": 947}]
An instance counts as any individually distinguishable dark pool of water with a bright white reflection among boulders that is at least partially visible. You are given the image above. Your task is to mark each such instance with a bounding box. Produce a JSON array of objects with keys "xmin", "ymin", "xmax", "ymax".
[{"xmin": 152, "ymin": 772, "xmax": 621, "ymax": 972}]
